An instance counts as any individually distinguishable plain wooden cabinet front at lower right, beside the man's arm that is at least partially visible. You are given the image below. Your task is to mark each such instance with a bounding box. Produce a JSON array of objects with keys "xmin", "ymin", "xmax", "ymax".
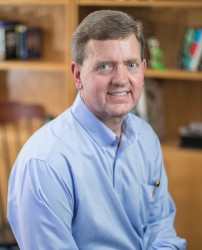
[{"xmin": 163, "ymin": 144, "xmax": 202, "ymax": 250}]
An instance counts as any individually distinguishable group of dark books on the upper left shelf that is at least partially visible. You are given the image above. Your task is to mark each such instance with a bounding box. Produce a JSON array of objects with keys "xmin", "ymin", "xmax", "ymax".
[{"xmin": 0, "ymin": 21, "xmax": 42, "ymax": 61}]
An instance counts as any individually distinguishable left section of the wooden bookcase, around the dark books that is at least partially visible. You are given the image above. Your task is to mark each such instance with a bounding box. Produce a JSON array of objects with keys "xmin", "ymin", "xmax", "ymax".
[{"xmin": 0, "ymin": 0, "xmax": 76, "ymax": 115}]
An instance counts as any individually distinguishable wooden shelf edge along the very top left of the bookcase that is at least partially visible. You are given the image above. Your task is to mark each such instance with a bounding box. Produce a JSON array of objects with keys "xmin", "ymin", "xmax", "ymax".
[{"xmin": 0, "ymin": 0, "xmax": 69, "ymax": 6}]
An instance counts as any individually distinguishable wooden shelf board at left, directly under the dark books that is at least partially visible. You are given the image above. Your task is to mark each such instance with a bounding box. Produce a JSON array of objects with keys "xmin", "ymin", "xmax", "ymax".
[{"xmin": 0, "ymin": 60, "xmax": 68, "ymax": 72}]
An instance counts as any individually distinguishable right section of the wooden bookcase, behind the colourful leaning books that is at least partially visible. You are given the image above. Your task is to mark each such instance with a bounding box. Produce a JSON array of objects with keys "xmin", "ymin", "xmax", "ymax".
[{"xmin": 76, "ymin": 0, "xmax": 202, "ymax": 138}]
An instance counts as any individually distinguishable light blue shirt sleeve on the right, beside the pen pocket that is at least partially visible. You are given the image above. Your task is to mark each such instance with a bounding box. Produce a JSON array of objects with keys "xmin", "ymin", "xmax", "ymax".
[{"xmin": 144, "ymin": 138, "xmax": 186, "ymax": 250}]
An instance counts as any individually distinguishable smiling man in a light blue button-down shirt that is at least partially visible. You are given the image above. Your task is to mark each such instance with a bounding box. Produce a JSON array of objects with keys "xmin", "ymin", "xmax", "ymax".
[{"xmin": 8, "ymin": 10, "xmax": 186, "ymax": 250}]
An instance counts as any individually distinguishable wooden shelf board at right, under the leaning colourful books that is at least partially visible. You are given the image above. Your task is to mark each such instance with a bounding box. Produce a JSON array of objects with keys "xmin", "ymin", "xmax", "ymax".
[{"xmin": 145, "ymin": 69, "xmax": 202, "ymax": 81}]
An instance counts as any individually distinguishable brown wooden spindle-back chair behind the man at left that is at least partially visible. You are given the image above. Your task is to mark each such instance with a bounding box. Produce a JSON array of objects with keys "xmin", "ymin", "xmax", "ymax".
[{"xmin": 0, "ymin": 102, "xmax": 46, "ymax": 249}]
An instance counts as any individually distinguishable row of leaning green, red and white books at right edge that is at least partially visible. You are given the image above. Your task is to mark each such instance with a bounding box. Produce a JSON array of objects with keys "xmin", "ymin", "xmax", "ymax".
[{"xmin": 179, "ymin": 27, "xmax": 202, "ymax": 71}]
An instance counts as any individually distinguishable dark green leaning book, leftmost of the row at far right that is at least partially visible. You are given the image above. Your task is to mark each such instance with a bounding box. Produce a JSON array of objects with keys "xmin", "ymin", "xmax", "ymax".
[{"xmin": 179, "ymin": 27, "xmax": 195, "ymax": 69}]
